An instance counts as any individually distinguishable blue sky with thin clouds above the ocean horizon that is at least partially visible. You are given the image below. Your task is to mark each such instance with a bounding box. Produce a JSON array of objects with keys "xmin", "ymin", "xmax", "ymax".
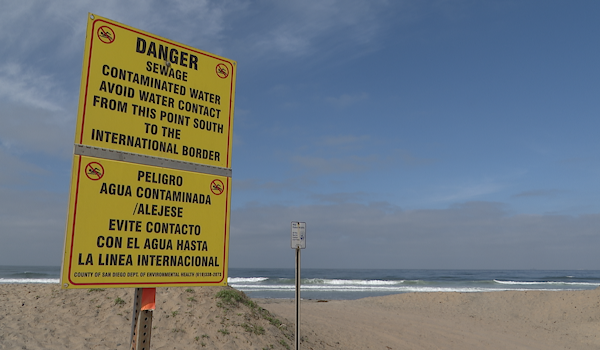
[{"xmin": 0, "ymin": 0, "xmax": 600, "ymax": 269}]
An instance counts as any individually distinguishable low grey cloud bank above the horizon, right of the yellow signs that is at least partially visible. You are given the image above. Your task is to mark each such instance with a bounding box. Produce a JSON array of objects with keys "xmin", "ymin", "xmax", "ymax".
[{"xmin": 230, "ymin": 202, "xmax": 600, "ymax": 269}]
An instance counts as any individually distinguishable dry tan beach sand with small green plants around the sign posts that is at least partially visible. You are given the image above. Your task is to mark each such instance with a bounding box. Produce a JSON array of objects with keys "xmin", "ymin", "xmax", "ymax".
[{"xmin": 0, "ymin": 284, "xmax": 600, "ymax": 350}]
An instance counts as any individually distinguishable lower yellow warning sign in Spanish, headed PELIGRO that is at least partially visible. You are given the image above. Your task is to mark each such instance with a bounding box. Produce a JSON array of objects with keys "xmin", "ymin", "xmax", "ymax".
[{"xmin": 62, "ymin": 156, "xmax": 231, "ymax": 288}]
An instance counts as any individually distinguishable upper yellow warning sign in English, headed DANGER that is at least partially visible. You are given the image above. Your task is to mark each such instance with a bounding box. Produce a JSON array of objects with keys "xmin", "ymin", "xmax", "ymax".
[{"xmin": 75, "ymin": 15, "xmax": 236, "ymax": 168}]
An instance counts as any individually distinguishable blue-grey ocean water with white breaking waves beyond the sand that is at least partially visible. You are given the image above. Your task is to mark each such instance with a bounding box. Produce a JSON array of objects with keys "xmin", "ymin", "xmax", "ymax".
[{"xmin": 0, "ymin": 266, "xmax": 600, "ymax": 300}]
